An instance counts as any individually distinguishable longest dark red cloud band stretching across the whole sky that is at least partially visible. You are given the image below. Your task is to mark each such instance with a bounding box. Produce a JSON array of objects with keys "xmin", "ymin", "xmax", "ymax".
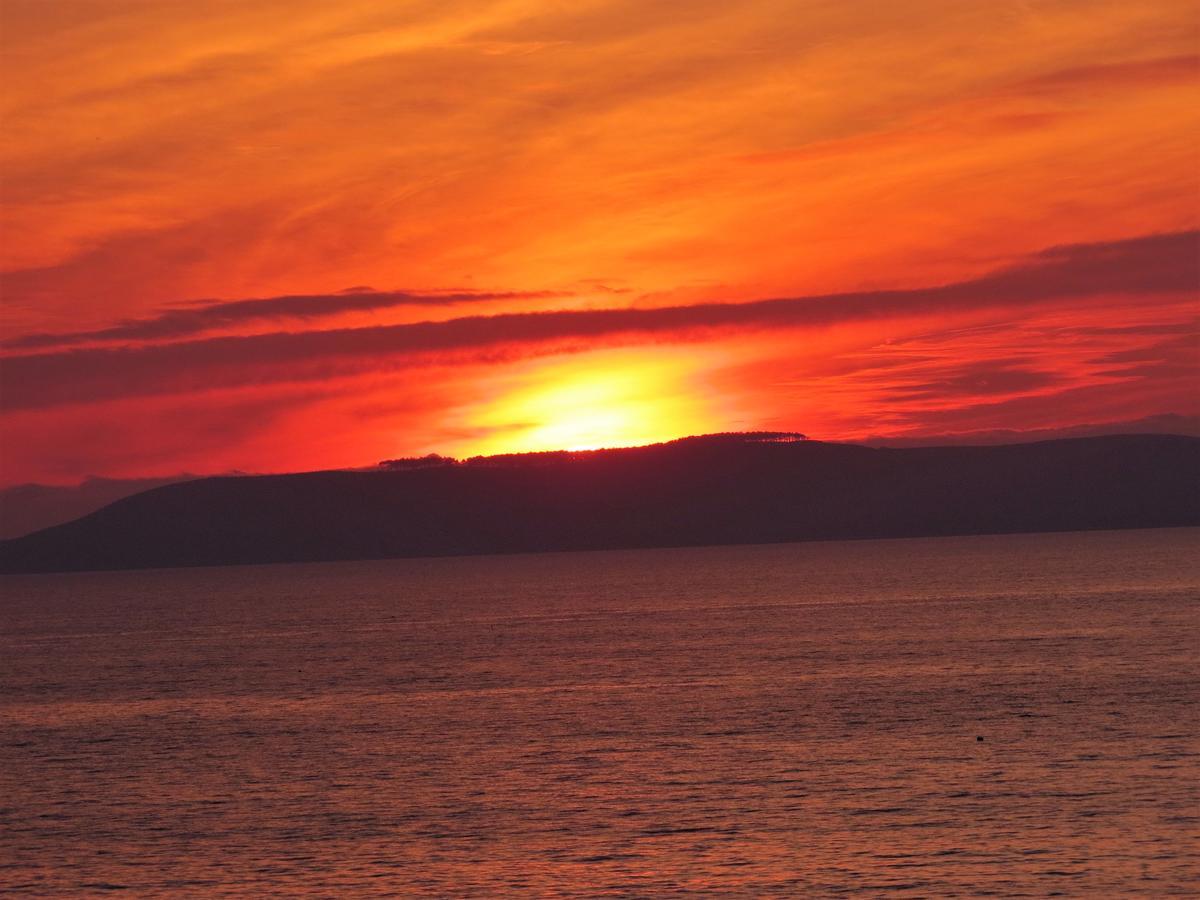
[{"xmin": 0, "ymin": 232, "xmax": 1200, "ymax": 409}]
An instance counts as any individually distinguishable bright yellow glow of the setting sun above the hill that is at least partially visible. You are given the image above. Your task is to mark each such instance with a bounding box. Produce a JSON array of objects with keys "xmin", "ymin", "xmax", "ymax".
[{"xmin": 458, "ymin": 353, "xmax": 718, "ymax": 455}]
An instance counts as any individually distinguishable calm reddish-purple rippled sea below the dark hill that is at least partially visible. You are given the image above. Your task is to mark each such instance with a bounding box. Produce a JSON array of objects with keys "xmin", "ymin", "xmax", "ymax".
[{"xmin": 0, "ymin": 529, "xmax": 1200, "ymax": 898}]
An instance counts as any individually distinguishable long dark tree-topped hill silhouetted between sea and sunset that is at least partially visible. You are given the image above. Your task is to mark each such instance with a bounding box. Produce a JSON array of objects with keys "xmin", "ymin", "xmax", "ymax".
[{"xmin": 0, "ymin": 434, "xmax": 1200, "ymax": 572}]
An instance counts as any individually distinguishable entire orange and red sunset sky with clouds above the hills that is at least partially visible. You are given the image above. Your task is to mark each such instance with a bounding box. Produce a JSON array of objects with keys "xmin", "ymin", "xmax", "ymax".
[{"xmin": 0, "ymin": 0, "xmax": 1200, "ymax": 485}]
